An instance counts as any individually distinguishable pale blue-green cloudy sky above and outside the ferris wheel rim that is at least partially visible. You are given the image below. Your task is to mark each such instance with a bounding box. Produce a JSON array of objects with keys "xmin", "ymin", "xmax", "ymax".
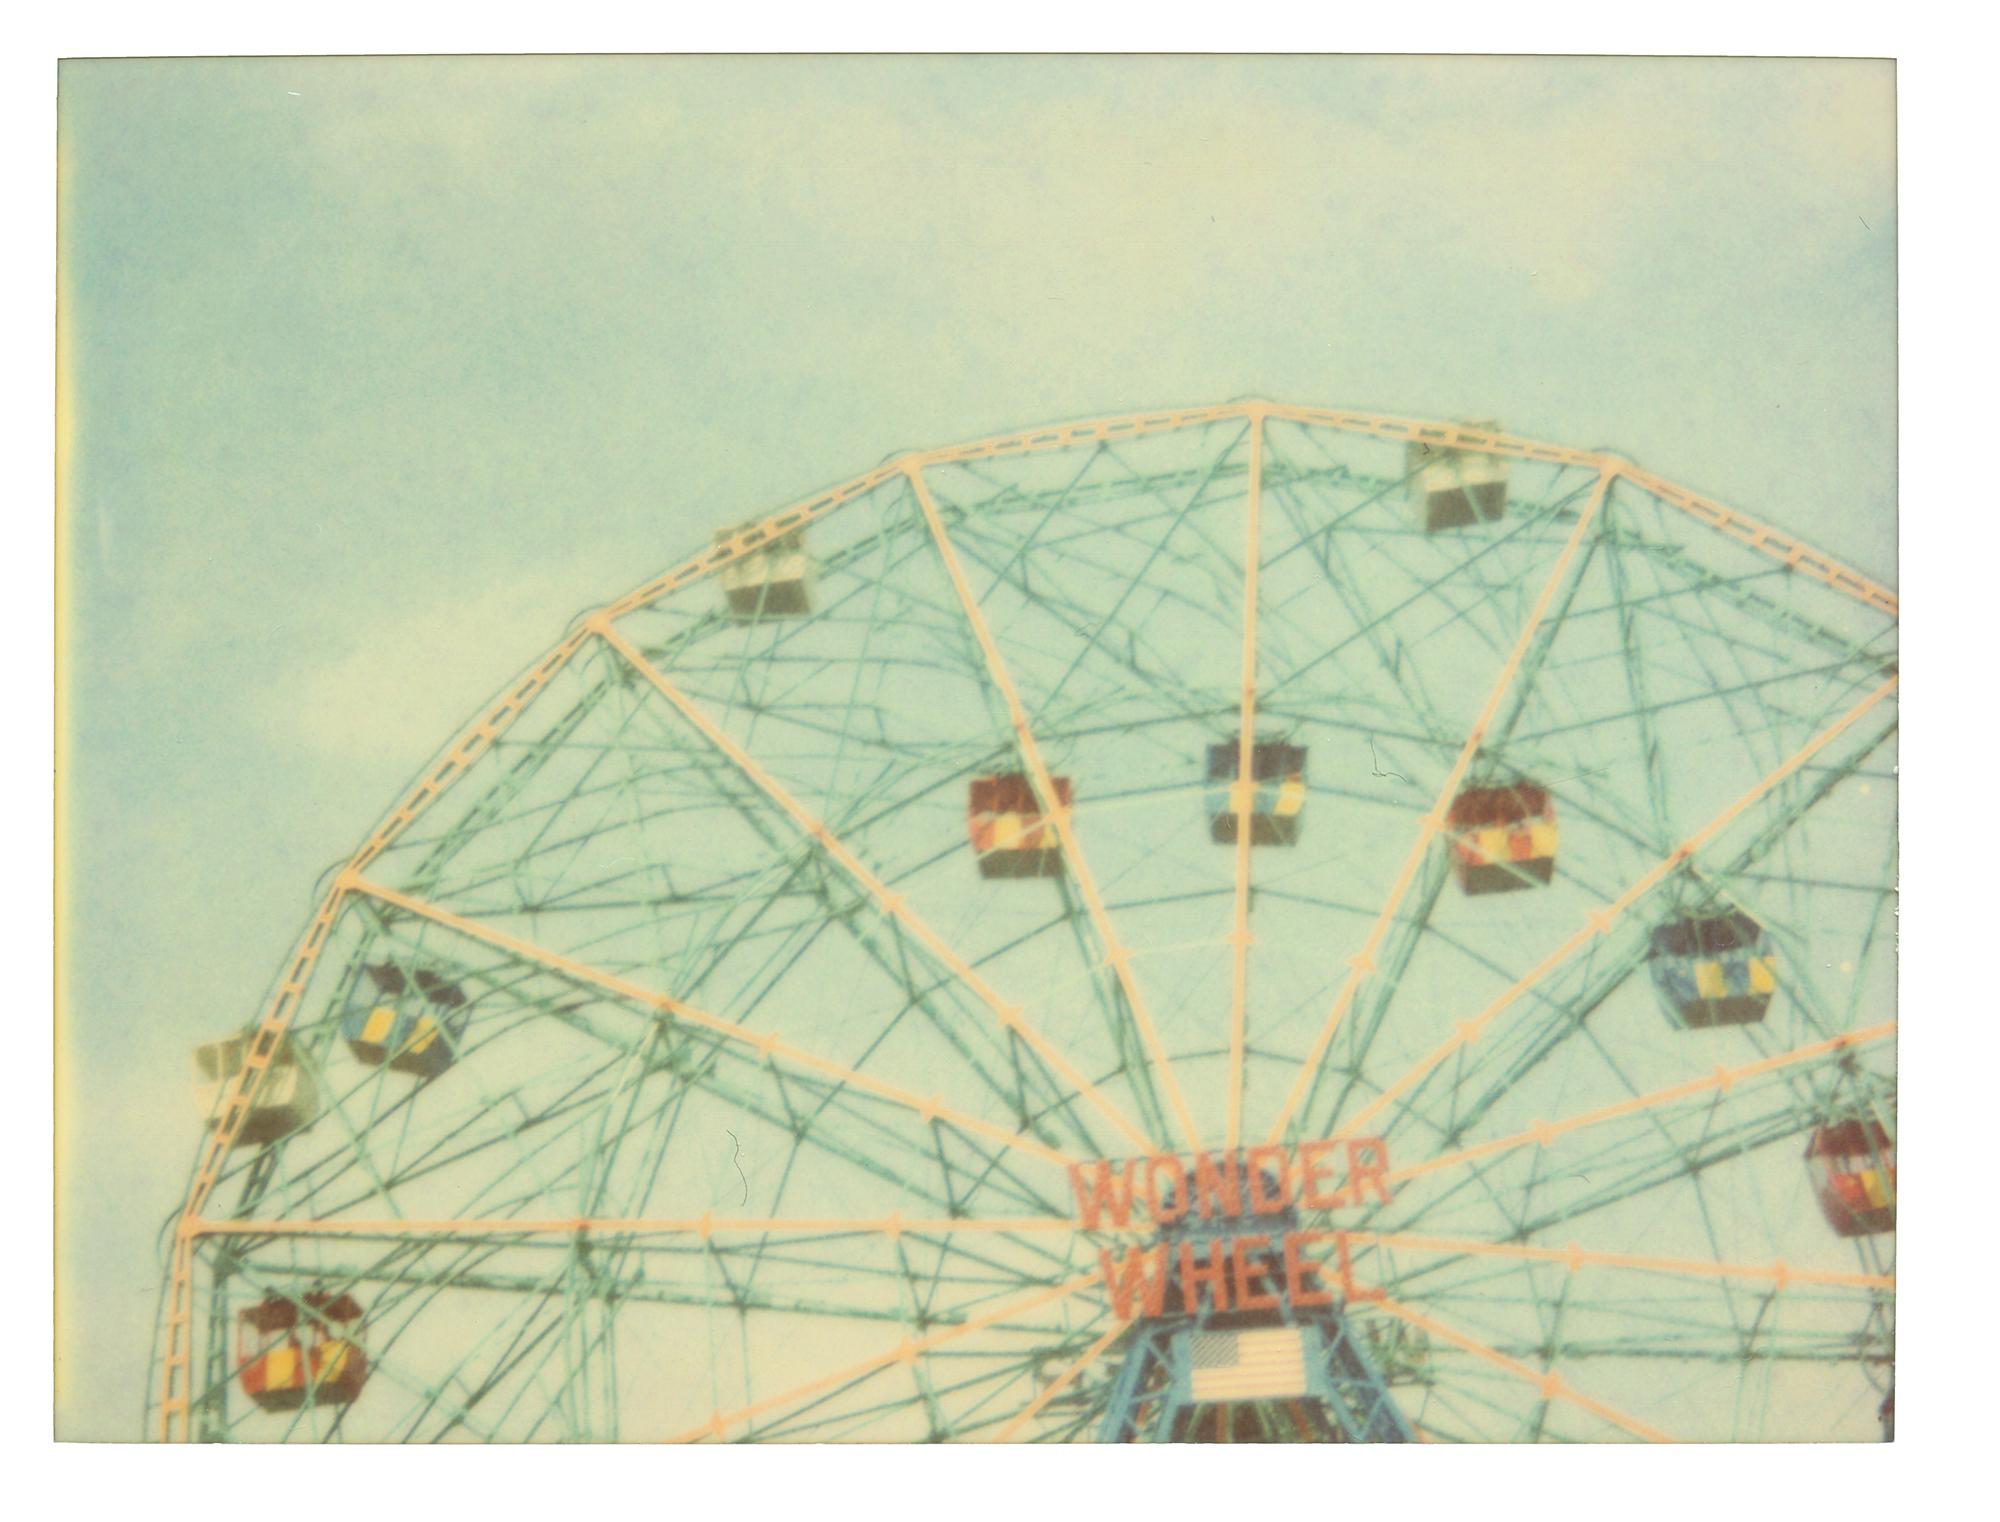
[{"xmin": 47, "ymin": 58, "xmax": 1896, "ymax": 1438}]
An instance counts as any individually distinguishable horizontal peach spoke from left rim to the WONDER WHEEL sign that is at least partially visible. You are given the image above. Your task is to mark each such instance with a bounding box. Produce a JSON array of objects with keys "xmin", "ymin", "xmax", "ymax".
[{"xmin": 188, "ymin": 1212, "xmax": 1080, "ymax": 1242}]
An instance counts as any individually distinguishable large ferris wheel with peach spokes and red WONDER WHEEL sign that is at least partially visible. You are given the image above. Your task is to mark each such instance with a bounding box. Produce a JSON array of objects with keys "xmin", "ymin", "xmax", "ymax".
[{"xmin": 146, "ymin": 402, "xmax": 1896, "ymax": 1442}]
